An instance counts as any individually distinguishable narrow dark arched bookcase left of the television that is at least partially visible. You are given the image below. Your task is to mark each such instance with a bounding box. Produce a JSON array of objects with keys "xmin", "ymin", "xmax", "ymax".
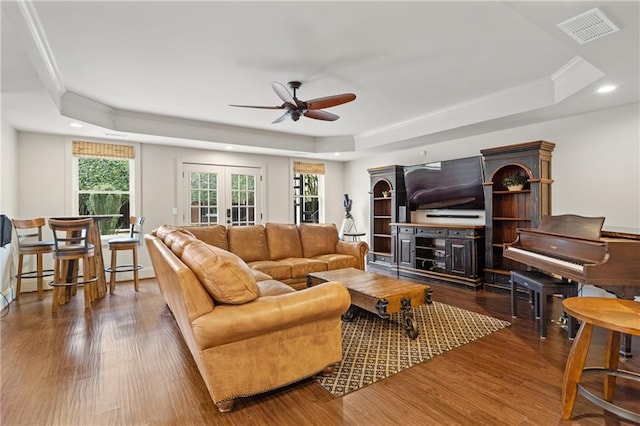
[{"xmin": 367, "ymin": 165, "xmax": 407, "ymax": 272}]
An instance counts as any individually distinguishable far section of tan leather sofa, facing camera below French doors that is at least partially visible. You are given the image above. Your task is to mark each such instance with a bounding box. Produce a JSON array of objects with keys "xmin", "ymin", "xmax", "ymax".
[{"xmin": 184, "ymin": 223, "xmax": 369, "ymax": 289}]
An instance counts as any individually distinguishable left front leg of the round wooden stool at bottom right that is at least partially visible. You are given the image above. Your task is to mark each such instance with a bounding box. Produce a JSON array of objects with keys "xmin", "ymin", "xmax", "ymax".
[{"xmin": 562, "ymin": 322, "xmax": 593, "ymax": 420}]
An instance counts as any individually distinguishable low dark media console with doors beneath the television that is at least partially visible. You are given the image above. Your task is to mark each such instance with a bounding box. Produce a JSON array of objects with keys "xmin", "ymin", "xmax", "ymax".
[{"xmin": 392, "ymin": 223, "xmax": 484, "ymax": 288}]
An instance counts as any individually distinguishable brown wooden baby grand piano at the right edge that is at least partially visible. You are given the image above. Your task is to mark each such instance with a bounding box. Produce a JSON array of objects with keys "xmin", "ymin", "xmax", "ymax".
[{"xmin": 503, "ymin": 214, "xmax": 640, "ymax": 356}]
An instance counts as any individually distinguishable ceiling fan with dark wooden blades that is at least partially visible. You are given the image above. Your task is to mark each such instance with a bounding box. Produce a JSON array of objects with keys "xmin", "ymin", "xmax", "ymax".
[{"xmin": 230, "ymin": 81, "xmax": 356, "ymax": 124}]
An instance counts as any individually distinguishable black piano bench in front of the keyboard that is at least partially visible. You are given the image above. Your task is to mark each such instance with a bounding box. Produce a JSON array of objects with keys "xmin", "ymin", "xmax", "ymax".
[{"xmin": 510, "ymin": 271, "xmax": 578, "ymax": 339}]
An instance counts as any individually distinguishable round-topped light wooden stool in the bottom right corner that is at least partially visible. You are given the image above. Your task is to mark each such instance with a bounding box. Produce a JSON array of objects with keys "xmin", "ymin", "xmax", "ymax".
[{"xmin": 562, "ymin": 297, "xmax": 640, "ymax": 422}]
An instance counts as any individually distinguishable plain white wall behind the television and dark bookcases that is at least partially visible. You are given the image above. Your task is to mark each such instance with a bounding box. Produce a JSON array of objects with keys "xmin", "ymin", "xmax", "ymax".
[{"xmin": 345, "ymin": 103, "xmax": 640, "ymax": 245}]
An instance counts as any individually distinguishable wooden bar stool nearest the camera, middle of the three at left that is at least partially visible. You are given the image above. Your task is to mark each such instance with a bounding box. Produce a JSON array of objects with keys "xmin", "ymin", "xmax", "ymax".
[{"xmin": 49, "ymin": 218, "xmax": 98, "ymax": 313}]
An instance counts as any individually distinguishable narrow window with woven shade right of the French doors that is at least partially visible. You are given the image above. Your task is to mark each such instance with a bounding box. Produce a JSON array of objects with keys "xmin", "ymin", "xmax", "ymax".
[{"xmin": 293, "ymin": 161, "xmax": 324, "ymax": 224}]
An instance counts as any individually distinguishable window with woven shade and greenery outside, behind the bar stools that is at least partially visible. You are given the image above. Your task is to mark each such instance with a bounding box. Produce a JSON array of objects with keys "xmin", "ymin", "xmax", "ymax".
[{"xmin": 72, "ymin": 141, "xmax": 134, "ymax": 235}]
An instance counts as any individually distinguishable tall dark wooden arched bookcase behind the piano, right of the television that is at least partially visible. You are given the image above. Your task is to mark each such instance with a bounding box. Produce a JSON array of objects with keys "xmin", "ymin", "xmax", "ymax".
[{"xmin": 481, "ymin": 141, "xmax": 555, "ymax": 290}]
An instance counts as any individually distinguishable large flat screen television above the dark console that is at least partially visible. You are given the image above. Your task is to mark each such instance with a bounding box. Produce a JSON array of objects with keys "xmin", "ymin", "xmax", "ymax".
[{"xmin": 404, "ymin": 156, "xmax": 484, "ymax": 210}]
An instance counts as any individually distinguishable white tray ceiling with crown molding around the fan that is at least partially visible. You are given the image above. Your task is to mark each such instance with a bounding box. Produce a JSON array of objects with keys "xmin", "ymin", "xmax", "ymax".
[{"xmin": 2, "ymin": 0, "xmax": 640, "ymax": 160}]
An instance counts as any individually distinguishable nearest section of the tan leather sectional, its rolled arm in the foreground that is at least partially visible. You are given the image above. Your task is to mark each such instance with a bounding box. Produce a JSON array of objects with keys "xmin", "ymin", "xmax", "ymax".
[{"xmin": 145, "ymin": 226, "xmax": 351, "ymax": 412}]
